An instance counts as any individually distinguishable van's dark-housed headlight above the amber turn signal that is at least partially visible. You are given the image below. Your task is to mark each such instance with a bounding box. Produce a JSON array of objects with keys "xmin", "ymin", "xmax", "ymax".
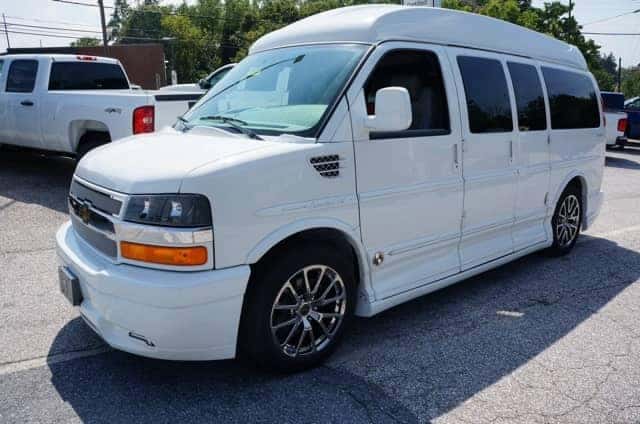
[{"xmin": 124, "ymin": 194, "xmax": 211, "ymax": 227}]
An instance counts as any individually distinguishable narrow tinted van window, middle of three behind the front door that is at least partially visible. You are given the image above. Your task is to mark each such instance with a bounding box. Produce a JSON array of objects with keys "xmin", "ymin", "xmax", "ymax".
[{"xmin": 507, "ymin": 62, "xmax": 547, "ymax": 131}]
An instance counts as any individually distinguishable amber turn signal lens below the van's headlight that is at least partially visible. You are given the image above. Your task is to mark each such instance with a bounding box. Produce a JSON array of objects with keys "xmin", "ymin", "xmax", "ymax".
[{"xmin": 120, "ymin": 241, "xmax": 207, "ymax": 266}]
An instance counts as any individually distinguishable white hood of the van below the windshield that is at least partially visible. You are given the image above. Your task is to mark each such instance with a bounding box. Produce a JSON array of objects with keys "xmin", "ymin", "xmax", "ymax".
[{"xmin": 76, "ymin": 129, "xmax": 272, "ymax": 194}]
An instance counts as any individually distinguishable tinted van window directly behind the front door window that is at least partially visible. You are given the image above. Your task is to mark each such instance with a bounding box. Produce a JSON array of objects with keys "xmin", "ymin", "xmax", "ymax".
[{"xmin": 458, "ymin": 56, "xmax": 513, "ymax": 133}]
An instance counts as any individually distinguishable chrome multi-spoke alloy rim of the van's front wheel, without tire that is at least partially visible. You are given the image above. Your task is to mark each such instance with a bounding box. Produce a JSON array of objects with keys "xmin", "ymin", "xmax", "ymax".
[{"xmin": 270, "ymin": 265, "xmax": 347, "ymax": 357}]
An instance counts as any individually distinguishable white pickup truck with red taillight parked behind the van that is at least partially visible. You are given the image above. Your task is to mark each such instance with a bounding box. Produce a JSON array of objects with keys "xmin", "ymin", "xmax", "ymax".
[{"xmin": 0, "ymin": 54, "xmax": 200, "ymax": 157}]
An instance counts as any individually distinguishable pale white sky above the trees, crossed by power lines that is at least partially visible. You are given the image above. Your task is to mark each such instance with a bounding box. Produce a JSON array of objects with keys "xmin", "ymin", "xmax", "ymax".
[{"xmin": 0, "ymin": 0, "xmax": 640, "ymax": 66}]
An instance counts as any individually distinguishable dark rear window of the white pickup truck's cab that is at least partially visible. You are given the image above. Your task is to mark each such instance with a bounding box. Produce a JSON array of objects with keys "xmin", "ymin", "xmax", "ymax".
[{"xmin": 49, "ymin": 62, "xmax": 129, "ymax": 90}]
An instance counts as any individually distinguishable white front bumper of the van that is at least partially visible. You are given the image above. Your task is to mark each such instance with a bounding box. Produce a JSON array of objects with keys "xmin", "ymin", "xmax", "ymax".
[{"xmin": 56, "ymin": 222, "xmax": 250, "ymax": 360}]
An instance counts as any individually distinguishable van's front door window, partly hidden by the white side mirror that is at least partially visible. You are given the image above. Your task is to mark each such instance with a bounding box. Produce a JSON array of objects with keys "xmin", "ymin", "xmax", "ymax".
[{"xmin": 364, "ymin": 50, "xmax": 451, "ymax": 138}]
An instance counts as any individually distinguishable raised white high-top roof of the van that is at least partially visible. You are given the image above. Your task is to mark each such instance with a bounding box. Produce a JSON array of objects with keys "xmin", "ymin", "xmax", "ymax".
[{"xmin": 250, "ymin": 5, "xmax": 587, "ymax": 70}]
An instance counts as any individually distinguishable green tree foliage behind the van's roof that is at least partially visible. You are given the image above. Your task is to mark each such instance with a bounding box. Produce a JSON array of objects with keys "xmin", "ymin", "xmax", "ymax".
[{"xmin": 95, "ymin": 0, "xmax": 633, "ymax": 90}]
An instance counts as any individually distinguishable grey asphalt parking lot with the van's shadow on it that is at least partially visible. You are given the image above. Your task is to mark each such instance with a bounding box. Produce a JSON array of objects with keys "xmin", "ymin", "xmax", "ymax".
[{"xmin": 0, "ymin": 149, "xmax": 640, "ymax": 423}]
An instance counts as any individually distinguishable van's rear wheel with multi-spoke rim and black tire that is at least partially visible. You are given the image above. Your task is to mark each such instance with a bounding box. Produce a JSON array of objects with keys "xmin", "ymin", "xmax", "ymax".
[{"xmin": 548, "ymin": 187, "xmax": 582, "ymax": 256}]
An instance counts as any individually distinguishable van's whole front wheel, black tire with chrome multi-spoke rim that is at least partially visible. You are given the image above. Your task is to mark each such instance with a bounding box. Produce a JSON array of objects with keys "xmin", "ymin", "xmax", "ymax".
[{"xmin": 241, "ymin": 243, "xmax": 356, "ymax": 372}]
